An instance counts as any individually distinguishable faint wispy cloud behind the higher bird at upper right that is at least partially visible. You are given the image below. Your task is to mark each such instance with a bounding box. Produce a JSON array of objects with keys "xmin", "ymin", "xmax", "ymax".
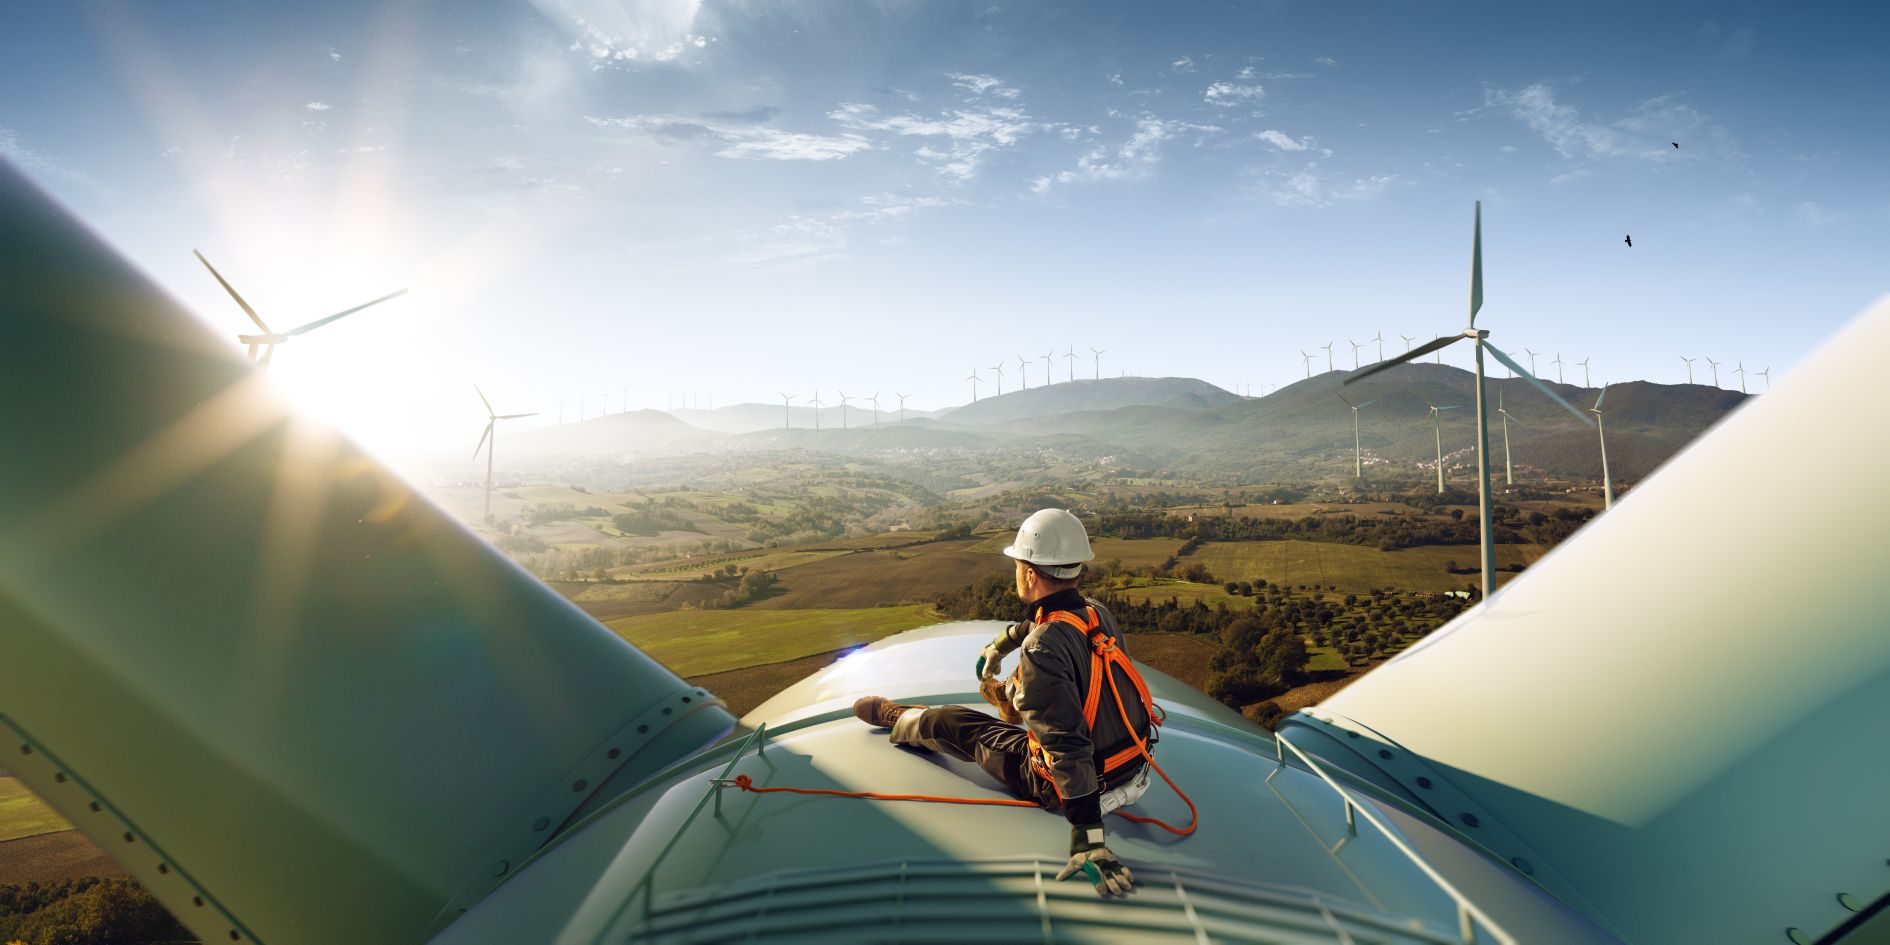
[{"xmin": 1470, "ymin": 83, "xmax": 1739, "ymax": 163}]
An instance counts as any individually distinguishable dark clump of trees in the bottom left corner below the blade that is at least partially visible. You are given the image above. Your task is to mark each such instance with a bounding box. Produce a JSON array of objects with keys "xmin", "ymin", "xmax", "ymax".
[{"xmin": 0, "ymin": 877, "xmax": 197, "ymax": 945}]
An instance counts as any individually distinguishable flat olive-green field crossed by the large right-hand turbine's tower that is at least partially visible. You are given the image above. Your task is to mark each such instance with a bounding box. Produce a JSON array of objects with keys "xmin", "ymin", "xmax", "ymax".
[{"xmin": 1183, "ymin": 541, "xmax": 1542, "ymax": 593}]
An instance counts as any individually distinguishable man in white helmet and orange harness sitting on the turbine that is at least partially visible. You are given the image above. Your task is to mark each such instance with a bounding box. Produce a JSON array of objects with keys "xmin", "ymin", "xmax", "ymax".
[{"xmin": 852, "ymin": 508, "xmax": 1153, "ymax": 896}]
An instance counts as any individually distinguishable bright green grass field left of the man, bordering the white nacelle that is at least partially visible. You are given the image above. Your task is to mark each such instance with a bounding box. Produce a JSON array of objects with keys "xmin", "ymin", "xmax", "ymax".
[{"xmin": 605, "ymin": 603, "xmax": 941, "ymax": 677}]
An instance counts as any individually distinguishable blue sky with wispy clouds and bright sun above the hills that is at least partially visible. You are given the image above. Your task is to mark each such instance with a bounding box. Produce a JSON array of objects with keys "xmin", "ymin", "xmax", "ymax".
[{"xmin": 0, "ymin": 0, "xmax": 1890, "ymax": 457}]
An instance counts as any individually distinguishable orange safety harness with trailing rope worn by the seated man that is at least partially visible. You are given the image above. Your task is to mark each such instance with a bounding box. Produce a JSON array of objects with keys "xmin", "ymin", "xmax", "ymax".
[{"xmin": 735, "ymin": 607, "xmax": 1200, "ymax": 837}]
